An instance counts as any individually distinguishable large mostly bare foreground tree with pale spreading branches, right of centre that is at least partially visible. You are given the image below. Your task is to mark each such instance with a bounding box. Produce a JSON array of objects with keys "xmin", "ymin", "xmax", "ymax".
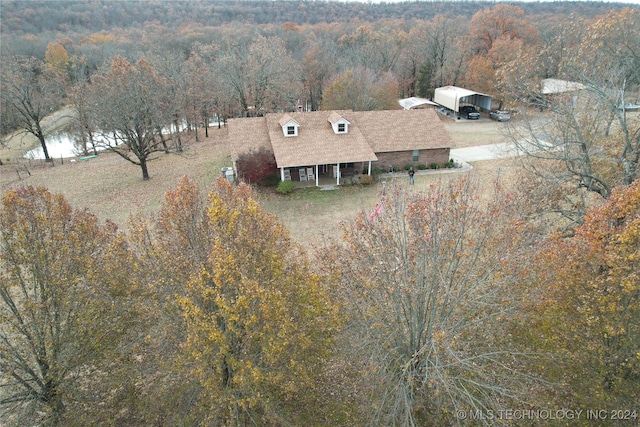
[{"xmin": 323, "ymin": 180, "xmax": 527, "ymax": 426}]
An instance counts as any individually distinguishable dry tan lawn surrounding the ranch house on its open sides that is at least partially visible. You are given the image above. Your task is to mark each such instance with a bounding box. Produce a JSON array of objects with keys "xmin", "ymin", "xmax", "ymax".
[{"xmin": 0, "ymin": 115, "xmax": 516, "ymax": 249}]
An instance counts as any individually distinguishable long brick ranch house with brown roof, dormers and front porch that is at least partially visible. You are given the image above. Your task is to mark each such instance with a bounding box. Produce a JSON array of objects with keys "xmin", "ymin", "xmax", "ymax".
[{"xmin": 228, "ymin": 109, "xmax": 453, "ymax": 186}]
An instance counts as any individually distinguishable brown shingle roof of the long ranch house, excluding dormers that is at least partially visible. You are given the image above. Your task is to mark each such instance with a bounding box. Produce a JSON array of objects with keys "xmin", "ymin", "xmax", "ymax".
[{"xmin": 228, "ymin": 109, "xmax": 453, "ymax": 167}]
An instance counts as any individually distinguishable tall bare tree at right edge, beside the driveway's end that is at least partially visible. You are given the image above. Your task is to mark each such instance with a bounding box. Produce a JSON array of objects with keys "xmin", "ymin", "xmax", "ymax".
[{"xmin": 501, "ymin": 10, "xmax": 640, "ymax": 222}]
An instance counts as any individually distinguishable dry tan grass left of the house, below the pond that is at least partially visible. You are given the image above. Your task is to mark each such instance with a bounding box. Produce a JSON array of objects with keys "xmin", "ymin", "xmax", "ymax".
[{"xmin": 0, "ymin": 129, "xmax": 231, "ymax": 224}]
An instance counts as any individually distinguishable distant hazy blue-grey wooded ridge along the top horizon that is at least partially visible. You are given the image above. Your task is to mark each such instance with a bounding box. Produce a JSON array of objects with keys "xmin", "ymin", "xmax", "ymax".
[{"xmin": 1, "ymin": 0, "xmax": 625, "ymax": 34}]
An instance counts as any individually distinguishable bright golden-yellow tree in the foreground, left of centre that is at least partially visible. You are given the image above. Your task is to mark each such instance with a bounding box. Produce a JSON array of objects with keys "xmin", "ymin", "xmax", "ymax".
[{"xmin": 146, "ymin": 178, "xmax": 336, "ymax": 425}]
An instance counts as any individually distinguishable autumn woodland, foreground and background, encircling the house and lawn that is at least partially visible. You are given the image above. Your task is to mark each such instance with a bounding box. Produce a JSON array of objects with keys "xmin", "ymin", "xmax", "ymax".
[{"xmin": 0, "ymin": 1, "xmax": 640, "ymax": 427}]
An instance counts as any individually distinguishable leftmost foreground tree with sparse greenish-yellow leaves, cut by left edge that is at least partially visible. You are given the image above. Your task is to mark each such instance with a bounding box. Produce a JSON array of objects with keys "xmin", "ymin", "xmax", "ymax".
[{"xmin": 0, "ymin": 187, "xmax": 135, "ymax": 426}]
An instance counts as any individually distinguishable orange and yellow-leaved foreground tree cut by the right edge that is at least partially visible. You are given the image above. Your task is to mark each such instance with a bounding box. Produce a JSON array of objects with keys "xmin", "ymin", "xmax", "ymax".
[{"xmin": 518, "ymin": 181, "xmax": 640, "ymax": 411}]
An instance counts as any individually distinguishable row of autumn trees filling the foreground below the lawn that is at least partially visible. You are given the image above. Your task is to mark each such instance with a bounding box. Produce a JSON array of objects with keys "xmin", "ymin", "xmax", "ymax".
[{"xmin": 0, "ymin": 177, "xmax": 640, "ymax": 426}]
